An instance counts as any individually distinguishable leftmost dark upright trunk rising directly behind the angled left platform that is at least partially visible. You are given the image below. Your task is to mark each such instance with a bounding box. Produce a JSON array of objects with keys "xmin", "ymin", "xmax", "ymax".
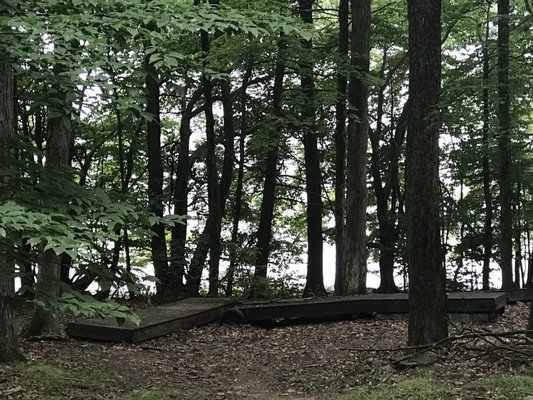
[{"xmin": 144, "ymin": 56, "xmax": 170, "ymax": 302}]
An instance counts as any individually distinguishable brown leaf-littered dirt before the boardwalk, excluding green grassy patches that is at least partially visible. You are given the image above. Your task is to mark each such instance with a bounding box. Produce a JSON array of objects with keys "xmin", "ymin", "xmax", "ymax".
[{"xmin": 0, "ymin": 305, "xmax": 533, "ymax": 400}]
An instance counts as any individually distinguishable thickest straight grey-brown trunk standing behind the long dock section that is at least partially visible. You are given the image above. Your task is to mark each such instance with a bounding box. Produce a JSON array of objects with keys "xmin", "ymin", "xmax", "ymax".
[{"xmin": 336, "ymin": 0, "xmax": 370, "ymax": 295}]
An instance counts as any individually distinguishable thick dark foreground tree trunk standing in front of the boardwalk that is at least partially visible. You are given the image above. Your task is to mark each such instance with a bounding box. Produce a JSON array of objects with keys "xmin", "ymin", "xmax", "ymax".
[{"xmin": 406, "ymin": 0, "xmax": 448, "ymax": 346}]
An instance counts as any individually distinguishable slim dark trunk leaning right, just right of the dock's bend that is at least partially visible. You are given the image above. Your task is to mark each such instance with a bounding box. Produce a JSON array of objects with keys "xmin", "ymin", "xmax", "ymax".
[{"xmin": 252, "ymin": 38, "xmax": 286, "ymax": 297}]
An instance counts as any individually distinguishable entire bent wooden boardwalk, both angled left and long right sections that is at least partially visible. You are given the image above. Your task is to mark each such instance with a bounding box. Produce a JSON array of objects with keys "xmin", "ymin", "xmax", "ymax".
[{"xmin": 67, "ymin": 290, "xmax": 533, "ymax": 342}]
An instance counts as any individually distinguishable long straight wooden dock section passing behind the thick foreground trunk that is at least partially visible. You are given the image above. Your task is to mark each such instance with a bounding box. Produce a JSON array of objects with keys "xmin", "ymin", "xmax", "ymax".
[{"xmin": 222, "ymin": 292, "xmax": 507, "ymax": 323}]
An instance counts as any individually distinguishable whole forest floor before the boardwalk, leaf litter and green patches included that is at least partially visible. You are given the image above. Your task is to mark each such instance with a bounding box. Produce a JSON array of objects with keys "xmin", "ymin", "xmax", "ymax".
[{"xmin": 0, "ymin": 304, "xmax": 533, "ymax": 400}]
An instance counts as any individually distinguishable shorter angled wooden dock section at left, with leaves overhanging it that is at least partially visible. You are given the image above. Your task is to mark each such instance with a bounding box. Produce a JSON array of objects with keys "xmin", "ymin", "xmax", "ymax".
[{"xmin": 67, "ymin": 297, "xmax": 236, "ymax": 342}]
